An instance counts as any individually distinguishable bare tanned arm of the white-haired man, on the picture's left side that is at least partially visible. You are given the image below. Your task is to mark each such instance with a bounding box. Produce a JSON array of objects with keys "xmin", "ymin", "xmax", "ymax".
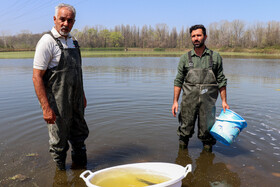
[{"xmin": 32, "ymin": 68, "xmax": 56, "ymax": 124}]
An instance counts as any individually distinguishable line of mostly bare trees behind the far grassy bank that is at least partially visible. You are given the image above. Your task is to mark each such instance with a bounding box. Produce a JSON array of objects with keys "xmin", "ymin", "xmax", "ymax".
[{"xmin": 0, "ymin": 20, "xmax": 280, "ymax": 50}]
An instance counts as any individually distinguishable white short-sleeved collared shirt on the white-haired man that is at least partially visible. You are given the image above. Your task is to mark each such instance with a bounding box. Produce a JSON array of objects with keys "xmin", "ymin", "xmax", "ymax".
[{"xmin": 33, "ymin": 27, "xmax": 75, "ymax": 70}]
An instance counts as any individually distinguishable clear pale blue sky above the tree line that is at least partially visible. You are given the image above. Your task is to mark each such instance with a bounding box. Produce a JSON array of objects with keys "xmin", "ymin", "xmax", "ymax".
[{"xmin": 0, "ymin": 0, "xmax": 280, "ymax": 36}]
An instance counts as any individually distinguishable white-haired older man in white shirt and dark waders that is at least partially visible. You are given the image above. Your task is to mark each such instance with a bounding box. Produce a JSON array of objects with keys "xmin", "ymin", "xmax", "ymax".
[{"xmin": 33, "ymin": 4, "xmax": 89, "ymax": 170}]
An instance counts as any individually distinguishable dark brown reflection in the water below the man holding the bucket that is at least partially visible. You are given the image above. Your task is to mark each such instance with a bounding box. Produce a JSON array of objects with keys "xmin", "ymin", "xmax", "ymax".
[{"xmin": 175, "ymin": 148, "xmax": 241, "ymax": 187}]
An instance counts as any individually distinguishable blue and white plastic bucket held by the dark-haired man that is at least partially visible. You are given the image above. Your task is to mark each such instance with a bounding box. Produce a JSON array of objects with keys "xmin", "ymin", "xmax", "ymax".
[{"xmin": 210, "ymin": 109, "xmax": 247, "ymax": 145}]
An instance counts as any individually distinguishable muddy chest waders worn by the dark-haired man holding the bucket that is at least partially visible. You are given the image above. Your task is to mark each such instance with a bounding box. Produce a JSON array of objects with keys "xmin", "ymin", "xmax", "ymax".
[{"xmin": 177, "ymin": 51, "xmax": 218, "ymax": 144}]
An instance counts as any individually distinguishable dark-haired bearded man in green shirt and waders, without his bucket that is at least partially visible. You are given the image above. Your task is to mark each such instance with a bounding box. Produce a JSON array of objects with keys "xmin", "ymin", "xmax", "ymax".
[{"xmin": 172, "ymin": 25, "xmax": 229, "ymax": 152}]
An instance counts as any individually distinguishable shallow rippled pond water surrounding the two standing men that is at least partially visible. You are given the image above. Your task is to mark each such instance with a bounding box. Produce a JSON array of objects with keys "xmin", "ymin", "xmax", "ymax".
[{"xmin": 0, "ymin": 57, "xmax": 280, "ymax": 186}]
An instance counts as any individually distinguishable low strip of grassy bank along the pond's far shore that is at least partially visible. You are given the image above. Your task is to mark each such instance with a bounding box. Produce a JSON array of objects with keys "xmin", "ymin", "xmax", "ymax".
[{"xmin": 0, "ymin": 48, "xmax": 280, "ymax": 59}]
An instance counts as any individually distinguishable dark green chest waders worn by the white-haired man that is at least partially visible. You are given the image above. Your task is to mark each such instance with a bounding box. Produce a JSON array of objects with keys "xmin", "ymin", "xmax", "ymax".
[{"xmin": 43, "ymin": 33, "xmax": 89, "ymax": 167}]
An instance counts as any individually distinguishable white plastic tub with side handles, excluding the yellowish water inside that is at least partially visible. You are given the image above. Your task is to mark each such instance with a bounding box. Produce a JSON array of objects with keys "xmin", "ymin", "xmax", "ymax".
[{"xmin": 80, "ymin": 162, "xmax": 192, "ymax": 187}]
